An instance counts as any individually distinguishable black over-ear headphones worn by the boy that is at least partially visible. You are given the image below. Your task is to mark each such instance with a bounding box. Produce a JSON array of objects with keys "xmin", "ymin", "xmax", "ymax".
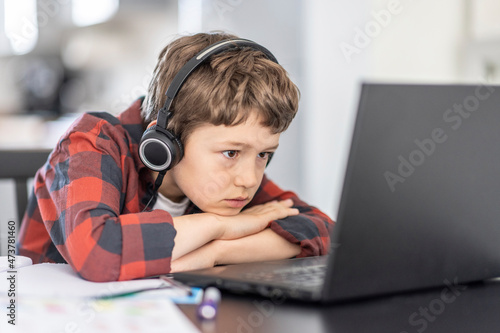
[{"xmin": 139, "ymin": 39, "xmax": 278, "ymax": 175}]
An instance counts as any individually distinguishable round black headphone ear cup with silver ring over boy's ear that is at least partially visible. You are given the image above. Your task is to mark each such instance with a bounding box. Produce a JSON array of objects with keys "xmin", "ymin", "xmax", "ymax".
[{"xmin": 139, "ymin": 125, "xmax": 184, "ymax": 172}]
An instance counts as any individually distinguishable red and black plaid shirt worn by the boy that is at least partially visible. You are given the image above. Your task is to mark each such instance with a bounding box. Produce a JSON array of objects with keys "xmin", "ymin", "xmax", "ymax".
[{"xmin": 18, "ymin": 100, "xmax": 333, "ymax": 281}]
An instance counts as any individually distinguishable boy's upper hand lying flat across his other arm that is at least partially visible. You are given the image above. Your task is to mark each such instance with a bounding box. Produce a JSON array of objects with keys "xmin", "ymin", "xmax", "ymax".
[{"xmin": 217, "ymin": 199, "xmax": 299, "ymax": 239}]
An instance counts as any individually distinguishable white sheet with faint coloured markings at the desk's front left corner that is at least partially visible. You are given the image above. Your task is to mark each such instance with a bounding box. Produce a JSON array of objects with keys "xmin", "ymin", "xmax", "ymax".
[{"xmin": 0, "ymin": 297, "xmax": 199, "ymax": 333}]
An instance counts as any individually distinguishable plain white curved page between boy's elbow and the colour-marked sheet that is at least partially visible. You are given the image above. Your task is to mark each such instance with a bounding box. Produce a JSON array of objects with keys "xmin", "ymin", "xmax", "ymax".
[{"xmin": 7, "ymin": 263, "xmax": 186, "ymax": 298}]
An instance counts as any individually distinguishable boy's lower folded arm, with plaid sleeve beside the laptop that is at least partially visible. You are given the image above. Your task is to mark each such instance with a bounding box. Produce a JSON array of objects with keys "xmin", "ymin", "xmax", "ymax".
[{"xmin": 171, "ymin": 177, "xmax": 334, "ymax": 272}]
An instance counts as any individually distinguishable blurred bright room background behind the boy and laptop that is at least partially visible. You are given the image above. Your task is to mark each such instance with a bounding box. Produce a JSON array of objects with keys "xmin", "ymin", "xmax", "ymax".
[{"xmin": 0, "ymin": 0, "xmax": 500, "ymax": 223}]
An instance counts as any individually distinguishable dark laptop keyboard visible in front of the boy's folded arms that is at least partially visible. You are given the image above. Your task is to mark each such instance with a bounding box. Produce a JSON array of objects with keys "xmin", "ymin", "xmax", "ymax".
[{"xmin": 243, "ymin": 265, "xmax": 326, "ymax": 287}]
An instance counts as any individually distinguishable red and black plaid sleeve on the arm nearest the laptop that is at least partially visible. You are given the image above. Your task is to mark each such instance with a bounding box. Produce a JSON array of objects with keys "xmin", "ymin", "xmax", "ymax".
[{"xmin": 251, "ymin": 176, "xmax": 334, "ymax": 258}]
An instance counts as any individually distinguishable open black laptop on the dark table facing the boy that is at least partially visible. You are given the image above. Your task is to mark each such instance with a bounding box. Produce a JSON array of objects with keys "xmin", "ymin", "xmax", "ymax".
[{"xmin": 173, "ymin": 83, "xmax": 500, "ymax": 302}]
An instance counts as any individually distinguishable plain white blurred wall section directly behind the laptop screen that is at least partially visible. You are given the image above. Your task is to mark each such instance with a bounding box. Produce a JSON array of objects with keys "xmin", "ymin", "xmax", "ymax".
[{"xmin": 302, "ymin": 0, "xmax": 472, "ymax": 217}]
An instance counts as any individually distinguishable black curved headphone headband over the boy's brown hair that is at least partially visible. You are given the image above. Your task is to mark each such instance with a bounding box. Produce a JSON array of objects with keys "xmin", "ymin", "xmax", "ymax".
[{"xmin": 157, "ymin": 39, "xmax": 278, "ymax": 129}]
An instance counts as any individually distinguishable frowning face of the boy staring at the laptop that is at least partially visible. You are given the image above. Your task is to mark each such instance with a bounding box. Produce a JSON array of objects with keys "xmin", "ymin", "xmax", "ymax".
[{"xmin": 160, "ymin": 112, "xmax": 280, "ymax": 215}]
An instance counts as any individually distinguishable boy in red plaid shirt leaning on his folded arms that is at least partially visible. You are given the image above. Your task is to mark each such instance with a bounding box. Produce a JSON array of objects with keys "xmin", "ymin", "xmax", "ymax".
[{"xmin": 19, "ymin": 33, "xmax": 333, "ymax": 281}]
